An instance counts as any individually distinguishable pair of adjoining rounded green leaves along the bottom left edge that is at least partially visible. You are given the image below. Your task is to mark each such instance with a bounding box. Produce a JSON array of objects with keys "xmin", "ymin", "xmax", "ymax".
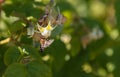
[{"xmin": 4, "ymin": 62, "xmax": 52, "ymax": 77}]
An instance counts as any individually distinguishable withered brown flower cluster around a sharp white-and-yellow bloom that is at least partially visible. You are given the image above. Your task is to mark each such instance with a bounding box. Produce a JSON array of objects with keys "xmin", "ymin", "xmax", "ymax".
[{"xmin": 28, "ymin": 6, "xmax": 66, "ymax": 51}]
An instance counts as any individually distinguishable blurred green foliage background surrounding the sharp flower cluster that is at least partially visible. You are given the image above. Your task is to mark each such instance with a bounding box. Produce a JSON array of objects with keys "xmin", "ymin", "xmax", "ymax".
[{"xmin": 0, "ymin": 0, "xmax": 120, "ymax": 77}]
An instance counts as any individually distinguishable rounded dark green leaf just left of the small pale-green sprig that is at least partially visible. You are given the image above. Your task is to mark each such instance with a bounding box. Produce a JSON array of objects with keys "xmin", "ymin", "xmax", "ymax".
[{"xmin": 4, "ymin": 46, "xmax": 21, "ymax": 65}]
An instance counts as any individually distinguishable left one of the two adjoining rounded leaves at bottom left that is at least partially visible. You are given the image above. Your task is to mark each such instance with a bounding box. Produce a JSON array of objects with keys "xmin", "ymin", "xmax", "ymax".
[{"xmin": 3, "ymin": 63, "xmax": 27, "ymax": 77}]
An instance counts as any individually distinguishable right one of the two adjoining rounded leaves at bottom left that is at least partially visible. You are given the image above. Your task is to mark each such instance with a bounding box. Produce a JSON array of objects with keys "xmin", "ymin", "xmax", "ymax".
[{"xmin": 26, "ymin": 61, "xmax": 52, "ymax": 77}]
